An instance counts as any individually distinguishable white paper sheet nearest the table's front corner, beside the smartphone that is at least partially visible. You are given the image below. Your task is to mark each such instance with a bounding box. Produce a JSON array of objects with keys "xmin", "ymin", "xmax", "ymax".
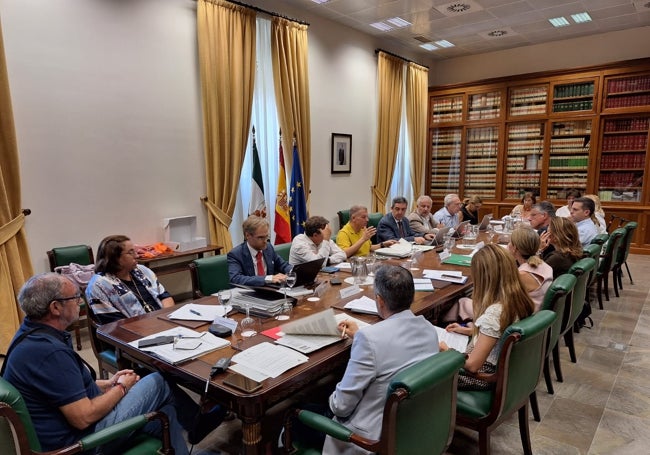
[{"xmin": 232, "ymin": 342, "xmax": 309, "ymax": 378}]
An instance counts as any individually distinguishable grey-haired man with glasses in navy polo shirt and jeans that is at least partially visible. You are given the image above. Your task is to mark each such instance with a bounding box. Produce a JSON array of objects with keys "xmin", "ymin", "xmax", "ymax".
[{"xmin": 3, "ymin": 273, "xmax": 222, "ymax": 455}]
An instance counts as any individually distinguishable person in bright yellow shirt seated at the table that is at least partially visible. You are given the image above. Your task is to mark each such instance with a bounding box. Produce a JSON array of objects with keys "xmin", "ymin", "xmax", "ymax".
[{"xmin": 336, "ymin": 205, "xmax": 396, "ymax": 257}]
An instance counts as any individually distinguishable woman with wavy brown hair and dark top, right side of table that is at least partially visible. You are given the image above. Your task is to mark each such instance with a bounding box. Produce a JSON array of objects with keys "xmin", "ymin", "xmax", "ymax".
[{"xmin": 540, "ymin": 216, "xmax": 582, "ymax": 279}]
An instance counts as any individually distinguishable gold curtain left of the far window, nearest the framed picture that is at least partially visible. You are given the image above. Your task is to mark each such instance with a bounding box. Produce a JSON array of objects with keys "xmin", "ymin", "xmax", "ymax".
[{"xmin": 372, "ymin": 52, "xmax": 404, "ymax": 213}]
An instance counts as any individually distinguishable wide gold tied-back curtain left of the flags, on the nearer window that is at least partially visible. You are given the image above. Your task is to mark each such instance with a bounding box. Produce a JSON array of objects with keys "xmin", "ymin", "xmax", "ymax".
[{"xmin": 197, "ymin": 0, "xmax": 255, "ymax": 252}]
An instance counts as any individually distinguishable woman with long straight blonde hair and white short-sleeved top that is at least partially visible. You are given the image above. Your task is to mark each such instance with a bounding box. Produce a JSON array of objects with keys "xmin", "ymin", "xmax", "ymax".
[{"xmin": 440, "ymin": 244, "xmax": 535, "ymax": 390}]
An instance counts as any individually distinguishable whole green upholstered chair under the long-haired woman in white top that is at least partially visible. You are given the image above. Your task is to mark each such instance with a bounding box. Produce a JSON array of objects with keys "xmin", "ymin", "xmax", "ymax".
[{"xmin": 456, "ymin": 310, "xmax": 556, "ymax": 455}]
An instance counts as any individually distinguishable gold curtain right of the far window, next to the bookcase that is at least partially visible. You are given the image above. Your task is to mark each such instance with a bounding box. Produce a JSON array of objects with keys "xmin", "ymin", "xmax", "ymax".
[{"xmin": 406, "ymin": 63, "xmax": 429, "ymax": 198}]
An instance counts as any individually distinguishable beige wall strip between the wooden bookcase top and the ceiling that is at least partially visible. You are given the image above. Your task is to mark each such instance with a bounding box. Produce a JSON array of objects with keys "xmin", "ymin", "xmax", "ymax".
[{"xmin": 429, "ymin": 27, "xmax": 650, "ymax": 85}]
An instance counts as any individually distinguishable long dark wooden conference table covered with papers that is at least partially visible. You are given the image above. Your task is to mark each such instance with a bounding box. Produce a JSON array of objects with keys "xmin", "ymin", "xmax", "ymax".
[{"xmin": 97, "ymin": 240, "xmax": 480, "ymax": 454}]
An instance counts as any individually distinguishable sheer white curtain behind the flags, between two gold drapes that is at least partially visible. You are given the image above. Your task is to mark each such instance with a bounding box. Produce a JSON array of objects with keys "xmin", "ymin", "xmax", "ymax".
[{"xmin": 229, "ymin": 17, "xmax": 280, "ymax": 245}]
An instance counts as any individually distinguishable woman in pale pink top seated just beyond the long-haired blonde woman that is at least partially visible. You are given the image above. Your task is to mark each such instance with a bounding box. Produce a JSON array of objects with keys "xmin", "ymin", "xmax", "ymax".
[{"xmin": 508, "ymin": 226, "xmax": 553, "ymax": 311}]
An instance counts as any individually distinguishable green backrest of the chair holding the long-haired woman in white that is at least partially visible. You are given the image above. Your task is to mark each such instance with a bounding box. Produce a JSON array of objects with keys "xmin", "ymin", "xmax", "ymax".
[{"xmin": 490, "ymin": 310, "xmax": 556, "ymax": 420}]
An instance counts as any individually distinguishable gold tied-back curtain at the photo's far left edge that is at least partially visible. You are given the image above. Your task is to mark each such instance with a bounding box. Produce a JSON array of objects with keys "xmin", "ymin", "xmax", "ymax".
[{"xmin": 0, "ymin": 21, "xmax": 34, "ymax": 354}]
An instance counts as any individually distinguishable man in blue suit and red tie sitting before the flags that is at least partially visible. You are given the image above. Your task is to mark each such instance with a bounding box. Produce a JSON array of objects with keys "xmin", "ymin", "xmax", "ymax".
[{"xmin": 228, "ymin": 215, "xmax": 291, "ymax": 286}]
